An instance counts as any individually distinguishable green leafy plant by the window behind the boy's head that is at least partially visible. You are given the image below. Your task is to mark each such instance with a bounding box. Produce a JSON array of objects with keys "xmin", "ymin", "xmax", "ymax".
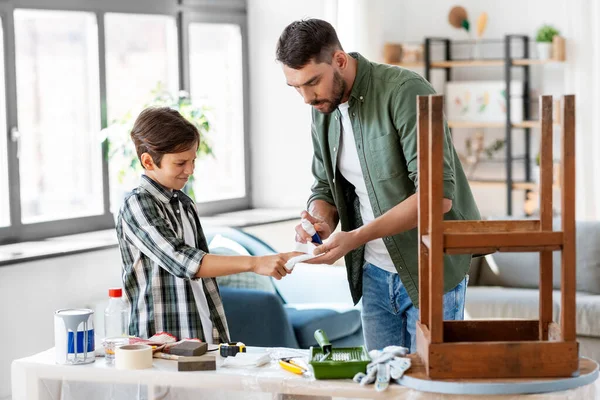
[{"xmin": 101, "ymin": 83, "xmax": 214, "ymax": 215}]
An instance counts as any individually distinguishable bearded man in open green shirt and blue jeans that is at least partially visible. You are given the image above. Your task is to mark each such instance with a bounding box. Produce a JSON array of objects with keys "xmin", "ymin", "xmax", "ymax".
[{"xmin": 276, "ymin": 19, "xmax": 479, "ymax": 352}]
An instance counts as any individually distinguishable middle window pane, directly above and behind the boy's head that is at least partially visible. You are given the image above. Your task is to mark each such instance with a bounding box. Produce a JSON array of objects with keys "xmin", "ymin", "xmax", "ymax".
[{"xmin": 104, "ymin": 13, "xmax": 179, "ymax": 209}]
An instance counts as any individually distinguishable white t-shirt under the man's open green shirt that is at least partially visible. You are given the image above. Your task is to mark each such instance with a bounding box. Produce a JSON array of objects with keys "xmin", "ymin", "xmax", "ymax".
[{"xmin": 338, "ymin": 103, "xmax": 397, "ymax": 273}]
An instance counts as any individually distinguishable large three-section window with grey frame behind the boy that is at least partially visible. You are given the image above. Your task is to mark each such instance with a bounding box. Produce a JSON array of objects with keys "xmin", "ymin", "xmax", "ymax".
[{"xmin": 0, "ymin": 0, "xmax": 249, "ymax": 245}]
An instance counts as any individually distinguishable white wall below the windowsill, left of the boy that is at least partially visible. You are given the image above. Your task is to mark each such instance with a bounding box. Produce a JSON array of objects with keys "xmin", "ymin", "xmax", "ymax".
[{"xmin": 0, "ymin": 248, "xmax": 121, "ymax": 398}]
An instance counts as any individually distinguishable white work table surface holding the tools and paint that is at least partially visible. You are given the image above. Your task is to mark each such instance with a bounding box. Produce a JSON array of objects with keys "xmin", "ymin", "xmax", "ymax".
[{"xmin": 12, "ymin": 348, "xmax": 600, "ymax": 400}]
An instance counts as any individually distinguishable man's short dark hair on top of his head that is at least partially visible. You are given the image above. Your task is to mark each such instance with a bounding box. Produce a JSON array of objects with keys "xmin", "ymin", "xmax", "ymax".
[{"xmin": 275, "ymin": 19, "xmax": 343, "ymax": 69}]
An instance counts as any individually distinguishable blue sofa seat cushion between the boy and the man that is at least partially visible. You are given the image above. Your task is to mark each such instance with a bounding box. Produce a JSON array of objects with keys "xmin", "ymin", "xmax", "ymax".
[{"xmin": 286, "ymin": 306, "xmax": 361, "ymax": 348}]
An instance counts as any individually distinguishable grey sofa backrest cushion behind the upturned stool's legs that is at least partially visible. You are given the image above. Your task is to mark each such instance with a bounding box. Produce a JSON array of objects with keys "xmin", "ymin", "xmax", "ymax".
[{"xmin": 478, "ymin": 219, "xmax": 600, "ymax": 294}]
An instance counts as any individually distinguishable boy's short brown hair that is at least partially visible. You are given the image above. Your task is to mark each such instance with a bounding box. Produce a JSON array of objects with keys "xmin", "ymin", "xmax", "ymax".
[{"xmin": 131, "ymin": 107, "xmax": 200, "ymax": 167}]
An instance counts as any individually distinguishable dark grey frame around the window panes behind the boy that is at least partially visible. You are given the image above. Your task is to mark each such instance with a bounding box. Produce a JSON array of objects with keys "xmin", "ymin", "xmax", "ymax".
[{"xmin": 0, "ymin": 0, "xmax": 251, "ymax": 245}]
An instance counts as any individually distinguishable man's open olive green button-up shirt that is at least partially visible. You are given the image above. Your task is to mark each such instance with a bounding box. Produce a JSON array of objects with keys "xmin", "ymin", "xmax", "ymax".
[{"xmin": 308, "ymin": 53, "xmax": 480, "ymax": 307}]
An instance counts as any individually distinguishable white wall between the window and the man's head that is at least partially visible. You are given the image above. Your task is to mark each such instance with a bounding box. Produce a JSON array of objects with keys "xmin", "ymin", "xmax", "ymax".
[{"xmin": 248, "ymin": 0, "xmax": 331, "ymax": 209}]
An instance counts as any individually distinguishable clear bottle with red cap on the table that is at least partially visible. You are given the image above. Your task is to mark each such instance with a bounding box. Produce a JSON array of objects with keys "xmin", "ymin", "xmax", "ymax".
[{"xmin": 103, "ymin": 288, "xmax": 129, "ymax": 364}]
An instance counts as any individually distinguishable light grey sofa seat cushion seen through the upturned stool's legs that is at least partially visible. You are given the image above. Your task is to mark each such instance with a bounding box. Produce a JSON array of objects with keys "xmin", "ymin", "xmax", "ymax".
[{"xmin": 465, "ymin": 286, "xmax": 600, "ymax": 338}]
